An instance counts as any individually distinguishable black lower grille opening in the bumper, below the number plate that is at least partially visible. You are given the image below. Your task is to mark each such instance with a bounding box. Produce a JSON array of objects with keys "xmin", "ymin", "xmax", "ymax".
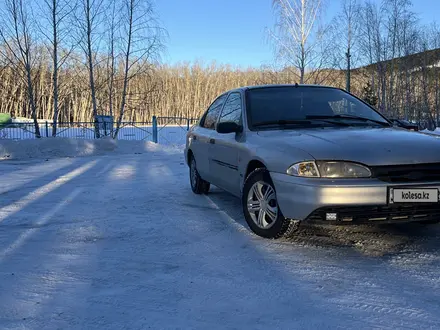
[{"xmin": 307, "ymin": 203, "xmax": 440, "ymax": 223}]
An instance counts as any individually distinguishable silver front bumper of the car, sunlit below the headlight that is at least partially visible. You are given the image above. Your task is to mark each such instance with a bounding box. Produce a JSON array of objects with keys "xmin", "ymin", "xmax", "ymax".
[{"xmin": 271, "ymin": 172, "xmax": 440, "ymax": 223}]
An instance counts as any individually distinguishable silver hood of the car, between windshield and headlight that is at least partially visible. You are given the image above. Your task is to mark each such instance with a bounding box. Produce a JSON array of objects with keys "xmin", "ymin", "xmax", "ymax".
[{"xmin": 258, "ymin": 128, "xmax": 440, "ymax": 166}]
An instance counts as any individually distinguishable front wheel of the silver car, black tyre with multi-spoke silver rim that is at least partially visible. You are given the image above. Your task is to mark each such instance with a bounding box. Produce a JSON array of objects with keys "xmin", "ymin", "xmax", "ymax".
[{"xmin": 242, "ymin": 168, "xmax": 297, "ymax": 238}]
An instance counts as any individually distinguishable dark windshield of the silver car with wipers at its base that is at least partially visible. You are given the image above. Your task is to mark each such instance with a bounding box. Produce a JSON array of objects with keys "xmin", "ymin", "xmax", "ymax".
[{"xmin": 246, "ymin": 86, "xmax": 390, "ymax": 129}]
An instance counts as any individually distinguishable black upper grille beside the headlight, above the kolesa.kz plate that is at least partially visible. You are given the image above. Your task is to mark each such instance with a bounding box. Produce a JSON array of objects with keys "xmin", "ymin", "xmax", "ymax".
[{"xmin": 371, "ymin": 163, "xmax": 440, "ymax": 183}]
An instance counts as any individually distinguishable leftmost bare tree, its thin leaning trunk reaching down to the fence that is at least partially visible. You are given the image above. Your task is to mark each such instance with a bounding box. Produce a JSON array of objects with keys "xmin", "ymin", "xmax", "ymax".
[{"xmin": 0, "ymin": 0, "xmax": 41, "ymax": 138}]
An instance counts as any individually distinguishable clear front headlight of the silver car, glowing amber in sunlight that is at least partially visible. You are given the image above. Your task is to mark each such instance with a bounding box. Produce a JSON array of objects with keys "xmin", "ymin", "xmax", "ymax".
[{"xmin": 287, "ymin": 161, "xmax": 371, "ymax": 178}]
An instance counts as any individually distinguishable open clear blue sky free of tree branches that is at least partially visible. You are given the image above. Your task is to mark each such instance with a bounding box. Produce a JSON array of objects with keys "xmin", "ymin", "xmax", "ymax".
[{"xmin": 156, "ymin": 0, "xmax": 440, "ymax": 67}]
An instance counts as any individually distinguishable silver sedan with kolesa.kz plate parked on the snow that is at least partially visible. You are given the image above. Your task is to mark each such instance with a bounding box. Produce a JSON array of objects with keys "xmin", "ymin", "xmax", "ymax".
[{"xmin": 185, "ymin": 85, "xmax": 440, "ymax": 238}]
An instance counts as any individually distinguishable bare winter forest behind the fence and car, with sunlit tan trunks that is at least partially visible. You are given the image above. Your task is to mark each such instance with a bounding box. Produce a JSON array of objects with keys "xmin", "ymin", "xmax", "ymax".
[{"xmin": 0, "ymin": 0, "xmax": 440, "ymax": 134}]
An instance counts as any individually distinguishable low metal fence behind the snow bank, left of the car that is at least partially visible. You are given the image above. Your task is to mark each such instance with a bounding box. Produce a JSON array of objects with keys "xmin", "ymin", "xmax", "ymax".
[{"xmin": 0, "ymin": 116, "xmax": 198, "ymax": 144}]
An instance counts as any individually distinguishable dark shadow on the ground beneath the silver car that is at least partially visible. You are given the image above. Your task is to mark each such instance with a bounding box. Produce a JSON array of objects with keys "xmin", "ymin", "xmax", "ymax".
[{"xmin": 209, "ymin": 187, "xmax": 440, "ymax": 256}]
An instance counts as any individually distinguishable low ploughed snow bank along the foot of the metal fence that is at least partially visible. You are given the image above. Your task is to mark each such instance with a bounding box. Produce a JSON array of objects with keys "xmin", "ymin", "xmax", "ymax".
[{"xmin": 0, "ymin": 137, "xmax": 183, "ymax": 160}]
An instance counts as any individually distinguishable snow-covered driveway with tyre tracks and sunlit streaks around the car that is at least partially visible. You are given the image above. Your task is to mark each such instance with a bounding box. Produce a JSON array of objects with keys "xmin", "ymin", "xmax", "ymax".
[{"xmin": 0, "ymin": 151, "xmax": 440, "ymax": 329}]
